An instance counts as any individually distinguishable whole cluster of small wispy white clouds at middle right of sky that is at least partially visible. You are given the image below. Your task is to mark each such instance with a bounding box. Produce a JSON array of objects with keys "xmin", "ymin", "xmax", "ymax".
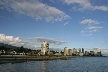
[{"xmin": 80, "ymin": 19, "xmax": 103, "ymax": 36}]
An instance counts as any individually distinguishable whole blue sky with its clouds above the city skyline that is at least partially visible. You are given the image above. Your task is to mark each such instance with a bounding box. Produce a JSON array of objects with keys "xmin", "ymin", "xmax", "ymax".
[{"xmin": 0, "ymin": 0, "xmax": 108, "ymax": 54}]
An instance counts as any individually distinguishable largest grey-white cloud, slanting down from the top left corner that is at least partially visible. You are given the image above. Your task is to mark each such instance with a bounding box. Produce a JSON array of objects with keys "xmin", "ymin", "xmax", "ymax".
[{"xmin": 0, "ymin": 0, "xmax": 70, "ymax": 22}]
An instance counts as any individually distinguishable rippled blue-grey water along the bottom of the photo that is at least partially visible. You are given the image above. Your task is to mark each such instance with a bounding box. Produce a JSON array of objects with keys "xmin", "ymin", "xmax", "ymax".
[{"xmin": 0, "ymin": 57, "xmax": 108, "ymax": 72}]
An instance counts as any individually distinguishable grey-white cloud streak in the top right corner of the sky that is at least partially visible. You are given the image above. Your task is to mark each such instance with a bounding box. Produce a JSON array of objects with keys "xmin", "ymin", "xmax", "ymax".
[{"xmin": 62, "ymin": 0, "xmax": 108, "ymax": 11}]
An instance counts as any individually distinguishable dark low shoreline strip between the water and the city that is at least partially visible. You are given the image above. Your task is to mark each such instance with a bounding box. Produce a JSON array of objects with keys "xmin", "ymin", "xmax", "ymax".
[{"xmin": 0, "ymin": 55, "xmax": 106, "ymax": 64}]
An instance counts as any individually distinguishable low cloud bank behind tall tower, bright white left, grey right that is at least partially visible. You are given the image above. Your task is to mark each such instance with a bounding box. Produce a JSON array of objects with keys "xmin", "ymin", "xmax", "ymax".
[{"xmin": 0, "ymin": 34, "xmax": 67, "ymax": 49}]
